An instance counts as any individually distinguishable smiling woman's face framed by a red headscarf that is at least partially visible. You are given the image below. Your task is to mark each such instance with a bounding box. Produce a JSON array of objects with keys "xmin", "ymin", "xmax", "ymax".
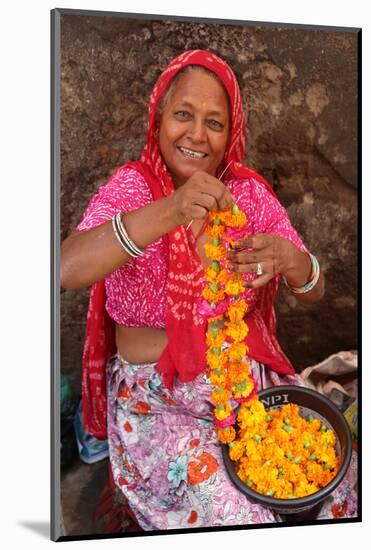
[{"xmin": 159, "ymin": 70, "xmax": 229, "ymax": 187}]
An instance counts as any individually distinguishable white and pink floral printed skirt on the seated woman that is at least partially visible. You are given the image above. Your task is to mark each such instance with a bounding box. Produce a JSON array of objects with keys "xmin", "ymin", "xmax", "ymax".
[{"xmin": 107, "ymin": 356, "xmax": 357, "ymax": 530}]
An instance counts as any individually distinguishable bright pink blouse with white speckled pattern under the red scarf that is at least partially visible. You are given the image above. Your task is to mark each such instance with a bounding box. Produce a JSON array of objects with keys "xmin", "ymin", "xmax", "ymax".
[{"xmin": 77, "ymin": 166, "xmax": 306, "ymax": 328}]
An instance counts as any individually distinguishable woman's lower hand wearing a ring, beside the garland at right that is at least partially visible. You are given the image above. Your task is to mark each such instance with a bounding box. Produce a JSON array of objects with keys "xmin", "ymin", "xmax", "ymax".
[{"xmin": 227, "ymin": 233, "xmax": 311, "ymax": 288}]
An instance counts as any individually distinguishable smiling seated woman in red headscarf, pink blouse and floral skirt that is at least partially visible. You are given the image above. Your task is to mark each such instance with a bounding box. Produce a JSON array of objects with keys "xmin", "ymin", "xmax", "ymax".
[{"xmin": 61, "ymin": 50, "xmax": 355, "ymax": 530}]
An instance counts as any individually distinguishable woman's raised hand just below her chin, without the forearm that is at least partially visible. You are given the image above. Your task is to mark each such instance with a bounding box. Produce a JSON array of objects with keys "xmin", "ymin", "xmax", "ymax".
[{"xmin": 168, "ymin": 171, "xmax": 234, "ymax": 225}]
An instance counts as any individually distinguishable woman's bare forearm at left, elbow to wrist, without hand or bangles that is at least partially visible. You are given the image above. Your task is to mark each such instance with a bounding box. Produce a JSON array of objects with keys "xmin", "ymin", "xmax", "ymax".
[{"xmin": 61, "ymin": 196, "xmax": 177, "ymax": 288}]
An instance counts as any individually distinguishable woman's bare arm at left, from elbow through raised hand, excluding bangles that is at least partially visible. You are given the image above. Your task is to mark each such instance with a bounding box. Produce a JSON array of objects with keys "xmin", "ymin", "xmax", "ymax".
[{"xmin": 61, "ymin": 172, "xmax": 233, "ymax": 288}]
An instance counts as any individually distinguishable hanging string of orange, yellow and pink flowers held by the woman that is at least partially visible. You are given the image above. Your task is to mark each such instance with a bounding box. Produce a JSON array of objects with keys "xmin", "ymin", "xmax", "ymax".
[{"xmin": 201, "ymin": 204, "xmax": 256, "ymax": 443}]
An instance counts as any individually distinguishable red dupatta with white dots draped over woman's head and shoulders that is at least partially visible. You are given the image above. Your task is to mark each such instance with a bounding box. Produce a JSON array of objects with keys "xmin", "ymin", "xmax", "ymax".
[{"xmin": 82, "ymin": 50, "xmax": 294, "ymax": 439}]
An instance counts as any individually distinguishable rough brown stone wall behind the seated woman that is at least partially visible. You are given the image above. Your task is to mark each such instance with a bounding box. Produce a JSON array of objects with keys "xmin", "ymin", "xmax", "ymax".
[{"xmin": 61, "ymin": 11, "xmax": 357, "ymax": 390}]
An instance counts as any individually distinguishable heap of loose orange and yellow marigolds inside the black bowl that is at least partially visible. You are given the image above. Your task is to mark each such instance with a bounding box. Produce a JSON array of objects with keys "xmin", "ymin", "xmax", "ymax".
[{"xmin": 232, "ymin": 402, "xmax": 340, "ymax": 498}]
